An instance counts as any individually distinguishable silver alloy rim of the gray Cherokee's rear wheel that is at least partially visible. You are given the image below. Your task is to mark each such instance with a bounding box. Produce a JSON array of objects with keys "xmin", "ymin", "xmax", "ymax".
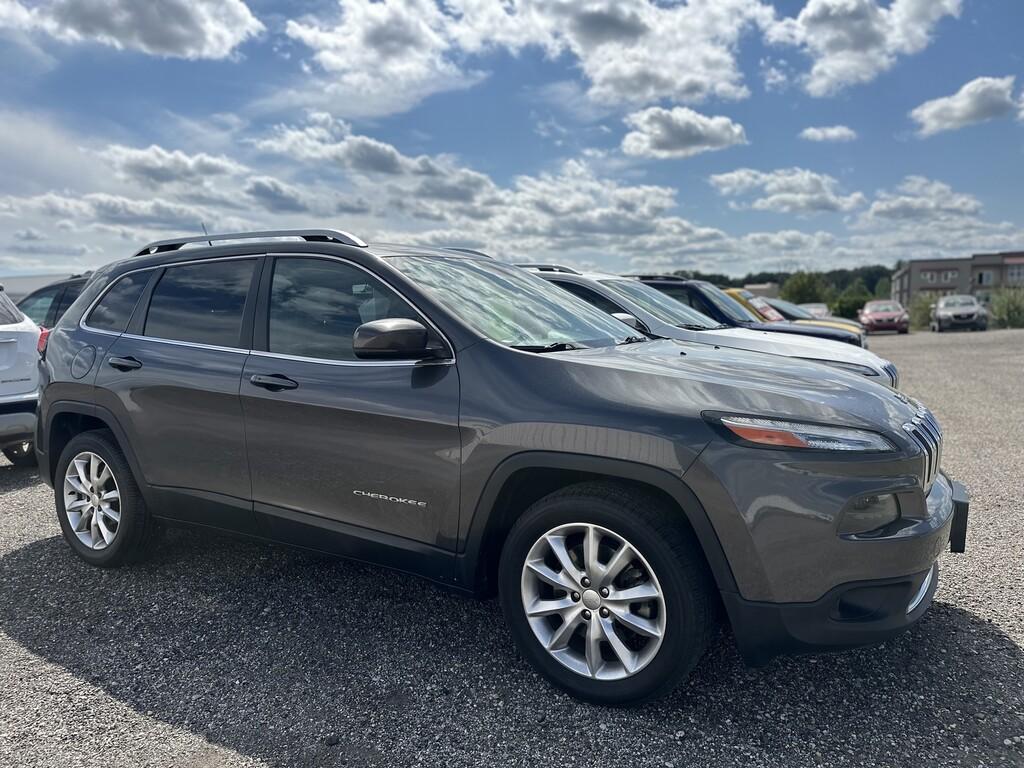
[{"xmin": 63, "ymin": 451, "xmax": 121, "ymax": 550}]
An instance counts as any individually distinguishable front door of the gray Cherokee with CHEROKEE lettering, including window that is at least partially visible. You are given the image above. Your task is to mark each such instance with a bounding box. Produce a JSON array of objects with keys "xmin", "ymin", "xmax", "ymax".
[{"xmin": 242, "ymin": 255, "xmax": 460, "ymax": 549}]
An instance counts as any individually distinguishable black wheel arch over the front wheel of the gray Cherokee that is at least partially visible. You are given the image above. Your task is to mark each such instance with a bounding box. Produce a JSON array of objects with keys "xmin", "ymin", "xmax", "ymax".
[{"xmin": 456, "ymin": 451, "xmax": 736, "ymax": 594}]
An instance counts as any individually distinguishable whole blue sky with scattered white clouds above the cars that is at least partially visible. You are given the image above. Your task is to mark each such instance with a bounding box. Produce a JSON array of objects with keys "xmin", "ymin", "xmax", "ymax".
[{"xmin": 0, "ymin": 0, "xmax": 1024, "ymax": 273}]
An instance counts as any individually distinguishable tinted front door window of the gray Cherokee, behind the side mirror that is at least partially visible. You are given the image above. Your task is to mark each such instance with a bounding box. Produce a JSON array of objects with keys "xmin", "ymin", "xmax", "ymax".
[{"xmin": 267, "ymin": 258, "xmax": 422, "ymax": 360}]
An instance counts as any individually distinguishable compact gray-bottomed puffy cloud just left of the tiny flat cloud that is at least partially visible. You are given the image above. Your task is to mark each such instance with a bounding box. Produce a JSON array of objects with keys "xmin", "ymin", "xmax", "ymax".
[{"xmin": 623, "ymin": 106, "xmax": 746, "ymax": 158}]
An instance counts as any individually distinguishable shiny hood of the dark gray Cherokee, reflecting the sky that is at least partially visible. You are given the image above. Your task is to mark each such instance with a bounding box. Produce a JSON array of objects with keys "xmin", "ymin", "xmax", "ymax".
[{"xmin": 543, "ymin": 340, "xmax": 915, "ymax": 434}]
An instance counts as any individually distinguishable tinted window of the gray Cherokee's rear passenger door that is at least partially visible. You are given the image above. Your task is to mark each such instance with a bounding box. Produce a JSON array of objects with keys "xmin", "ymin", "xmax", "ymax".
[{"xmin": 144, "ymin": 259, "xmax": 256, "ymax": 347}]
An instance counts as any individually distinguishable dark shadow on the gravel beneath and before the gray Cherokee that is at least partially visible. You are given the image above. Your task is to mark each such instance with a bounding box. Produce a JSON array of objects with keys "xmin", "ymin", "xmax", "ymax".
[{"xmin": 0, "ymin": 531, "xmax": 1024, "ymax": 766}]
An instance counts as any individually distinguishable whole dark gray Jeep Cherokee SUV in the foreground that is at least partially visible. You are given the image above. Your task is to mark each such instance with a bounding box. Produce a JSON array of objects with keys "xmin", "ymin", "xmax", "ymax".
[{"xmin": 37, "ymin": 230, "xmax": 967, "ymax": 703}]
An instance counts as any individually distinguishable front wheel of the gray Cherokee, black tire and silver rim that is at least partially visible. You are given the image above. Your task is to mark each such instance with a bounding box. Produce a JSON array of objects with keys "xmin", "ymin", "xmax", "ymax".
[{"xmin": 499, "ymin": 482, "xmax": 716, "ymax": 706}]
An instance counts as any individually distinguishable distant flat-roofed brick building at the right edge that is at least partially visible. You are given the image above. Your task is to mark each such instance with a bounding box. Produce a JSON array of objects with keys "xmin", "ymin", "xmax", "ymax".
[{"xmin": 892, "ymin": 256, "xmax": 1024, "ymax": 306}]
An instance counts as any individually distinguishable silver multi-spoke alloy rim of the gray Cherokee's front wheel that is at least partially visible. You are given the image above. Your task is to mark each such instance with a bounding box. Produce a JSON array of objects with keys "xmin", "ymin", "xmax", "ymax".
[{"xmin": 521, "ymin": 522, "xmax": 666, "ymax": 680}]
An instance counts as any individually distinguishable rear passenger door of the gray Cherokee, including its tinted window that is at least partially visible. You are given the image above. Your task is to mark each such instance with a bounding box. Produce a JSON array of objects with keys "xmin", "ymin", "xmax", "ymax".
[{"xmin": 95, "ymin": 256, "xmax": 262, "ymax": 526}]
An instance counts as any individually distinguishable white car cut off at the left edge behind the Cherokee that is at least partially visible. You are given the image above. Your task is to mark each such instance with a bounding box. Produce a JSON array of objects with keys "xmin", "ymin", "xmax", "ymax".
[{"xmin": 0, "ymin": 289, "xmax": 40, "ymax": 467}]
